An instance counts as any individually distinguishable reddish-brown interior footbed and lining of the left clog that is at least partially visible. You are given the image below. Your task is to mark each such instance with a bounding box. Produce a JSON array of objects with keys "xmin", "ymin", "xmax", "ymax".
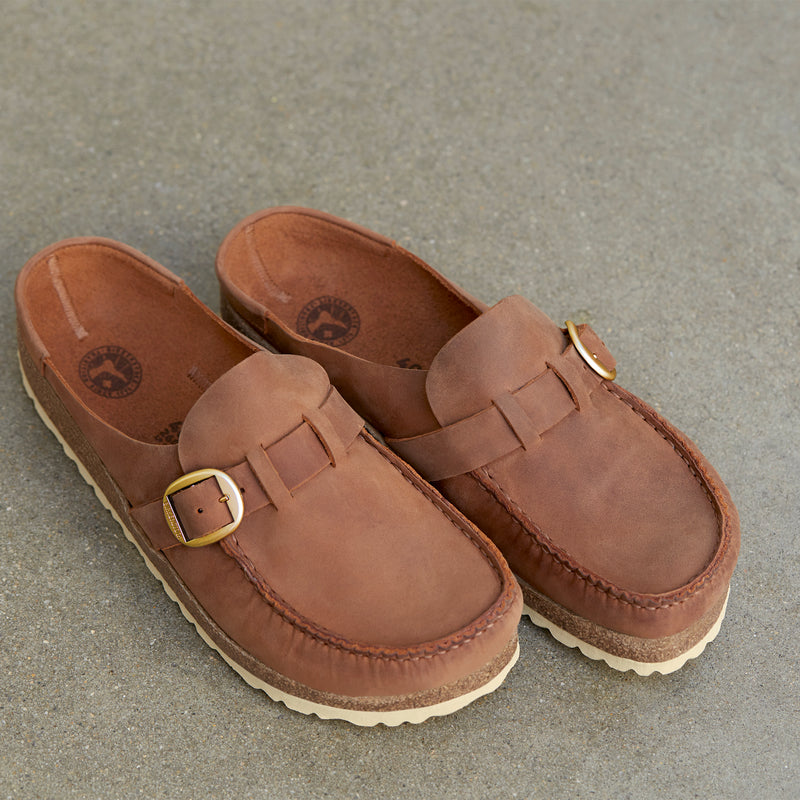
[{"xmin": 23, "ymin": 243, "xmax": 250, "ymax": 444}]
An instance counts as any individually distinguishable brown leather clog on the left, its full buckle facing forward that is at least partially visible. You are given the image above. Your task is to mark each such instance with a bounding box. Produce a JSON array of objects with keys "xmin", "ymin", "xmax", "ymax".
[{"xmin": 16, "ymin": 238, "xmax": 522, "ymax": 725}]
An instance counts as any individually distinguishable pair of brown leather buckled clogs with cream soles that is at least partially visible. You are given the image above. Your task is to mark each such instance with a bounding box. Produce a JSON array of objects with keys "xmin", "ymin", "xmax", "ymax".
[{"xmin": 16, "ymin": 208, "xmax": 739, "ymax": 725}]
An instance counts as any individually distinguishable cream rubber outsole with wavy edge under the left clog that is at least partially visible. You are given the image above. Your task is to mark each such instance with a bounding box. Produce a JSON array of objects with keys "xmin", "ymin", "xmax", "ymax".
[{"xmin": 20, "ymin": 363, "xmax": 519, "ymax": 727}]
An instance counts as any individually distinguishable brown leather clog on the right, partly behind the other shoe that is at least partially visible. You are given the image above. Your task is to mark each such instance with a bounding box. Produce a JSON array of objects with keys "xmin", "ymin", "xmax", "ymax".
[{"xmin": 217, "ymin": 208, "xmax": 739, "ymax": 675}]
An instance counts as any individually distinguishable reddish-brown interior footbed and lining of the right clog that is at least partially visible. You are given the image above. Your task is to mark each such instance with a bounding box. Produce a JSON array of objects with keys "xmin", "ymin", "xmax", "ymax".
[{"xmin": 226, "ymin": 212, "xmax": 478, "ymax": 369}]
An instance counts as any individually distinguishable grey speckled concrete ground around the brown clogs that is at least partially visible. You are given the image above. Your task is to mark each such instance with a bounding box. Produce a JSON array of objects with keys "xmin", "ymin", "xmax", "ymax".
[{"xmin": 0, "ymin": 0, "xmax": 800, "ymax": 800}]
